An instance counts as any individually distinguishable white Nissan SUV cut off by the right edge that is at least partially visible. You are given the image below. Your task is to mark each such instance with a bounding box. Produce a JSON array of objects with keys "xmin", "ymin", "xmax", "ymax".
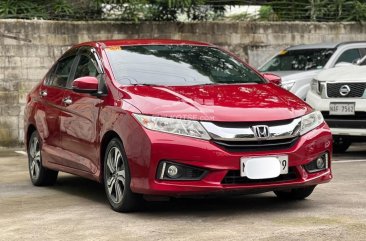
[{"xmin": 306, "ymin": 58, "xmax": 366, "ymax": 152}]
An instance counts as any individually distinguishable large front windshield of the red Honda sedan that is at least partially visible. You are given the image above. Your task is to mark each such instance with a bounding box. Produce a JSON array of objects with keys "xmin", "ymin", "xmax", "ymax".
[{"xmin": 106, "ymin": 45, "xmax": 265, "ymax": 86}]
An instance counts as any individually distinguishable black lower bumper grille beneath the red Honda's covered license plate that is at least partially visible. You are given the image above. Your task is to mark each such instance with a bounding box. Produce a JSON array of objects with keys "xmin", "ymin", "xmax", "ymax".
[{"xmin": 221, "ymin": 167, "xmax": 298, "ymax": 185}]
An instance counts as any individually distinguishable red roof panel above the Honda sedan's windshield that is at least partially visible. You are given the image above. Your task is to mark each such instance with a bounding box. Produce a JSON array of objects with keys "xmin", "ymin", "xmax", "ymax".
[{"xmin": 76, "ymin": 39, "xmax": 212, "ymax": 47}]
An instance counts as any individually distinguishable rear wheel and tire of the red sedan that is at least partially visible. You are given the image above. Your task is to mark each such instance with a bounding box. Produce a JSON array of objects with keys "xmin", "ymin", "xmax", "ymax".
[{"xmin": 27, "ymin": 131, "xmax": 58, "ymax": 186}]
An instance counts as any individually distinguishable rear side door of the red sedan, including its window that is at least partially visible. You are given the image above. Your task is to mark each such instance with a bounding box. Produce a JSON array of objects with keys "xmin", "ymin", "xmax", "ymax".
[{"xmin": 35, "ymin": 51, "xmax": 76, "ymax": 163}]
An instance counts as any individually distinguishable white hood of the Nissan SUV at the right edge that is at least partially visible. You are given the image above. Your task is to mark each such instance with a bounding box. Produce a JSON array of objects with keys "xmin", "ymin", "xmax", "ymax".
[{"xmin": 316, "ymin": 65, "xmax": 366, "ymax": 82}]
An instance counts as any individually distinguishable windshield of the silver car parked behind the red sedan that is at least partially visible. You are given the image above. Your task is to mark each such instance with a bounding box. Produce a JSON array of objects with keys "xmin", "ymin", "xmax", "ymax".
[{"xmin": 260, "ymin": 49, "xmax": 335, "ymax": 72}]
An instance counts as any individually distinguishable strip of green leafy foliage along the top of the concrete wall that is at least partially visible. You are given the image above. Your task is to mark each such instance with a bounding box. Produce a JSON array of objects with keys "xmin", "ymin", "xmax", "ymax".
[{"xmin": 0, "ymin": 0, "xmax": 366, "ymax": 21}]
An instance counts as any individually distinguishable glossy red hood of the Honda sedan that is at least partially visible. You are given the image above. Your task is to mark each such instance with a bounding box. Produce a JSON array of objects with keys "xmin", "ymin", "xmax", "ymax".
[{"xmin": 121, "ymin": 84, "xmax": 311, "ymax": 122}]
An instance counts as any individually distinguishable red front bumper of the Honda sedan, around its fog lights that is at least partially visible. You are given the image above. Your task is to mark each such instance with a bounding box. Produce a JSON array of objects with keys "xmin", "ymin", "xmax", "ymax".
[{"xmin": 126, "ymin": 121, "xmax": 332, "ymax": 196}]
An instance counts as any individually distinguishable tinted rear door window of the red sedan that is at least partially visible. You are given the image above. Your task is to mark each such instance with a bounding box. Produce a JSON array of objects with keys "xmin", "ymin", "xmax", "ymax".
[{"xmin": 48, "ymin": 56, "xmax": 75, "ymax": 88}]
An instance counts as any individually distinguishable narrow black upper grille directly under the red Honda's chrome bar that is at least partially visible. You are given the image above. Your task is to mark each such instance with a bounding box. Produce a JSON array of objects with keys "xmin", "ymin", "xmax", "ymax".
[{"xmin": 213, "ymin": 137, "xmax": 299, "ymax": 152}]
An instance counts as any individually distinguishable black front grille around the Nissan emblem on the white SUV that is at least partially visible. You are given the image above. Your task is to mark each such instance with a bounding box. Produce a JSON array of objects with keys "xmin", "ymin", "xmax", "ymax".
[{"xmin": 327, "ymin": 83, "xmax": 366, "ymax": 98}]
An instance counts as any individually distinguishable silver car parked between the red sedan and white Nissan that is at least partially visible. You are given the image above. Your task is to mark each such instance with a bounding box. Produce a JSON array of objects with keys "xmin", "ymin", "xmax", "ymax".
[{"xmin": 259, "ymin": 41, "xmax": 366, "ymax": 99}]
